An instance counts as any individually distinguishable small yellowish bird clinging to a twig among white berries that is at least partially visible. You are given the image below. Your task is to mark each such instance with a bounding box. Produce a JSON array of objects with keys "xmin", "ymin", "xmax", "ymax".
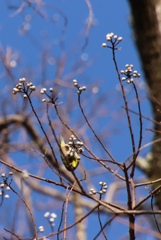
[{"xmin": 60, "ymin": 136, "xmax": 80, "ymax": 171}]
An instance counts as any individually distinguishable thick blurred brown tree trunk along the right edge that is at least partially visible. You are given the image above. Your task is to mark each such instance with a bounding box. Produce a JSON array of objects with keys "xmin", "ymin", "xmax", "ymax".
[{"xmin": 129, "ymin": 0, "xmax": 161, "ymax": 209}]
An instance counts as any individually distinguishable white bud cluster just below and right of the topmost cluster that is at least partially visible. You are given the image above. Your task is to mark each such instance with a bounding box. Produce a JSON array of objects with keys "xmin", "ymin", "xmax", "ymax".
[{"xmin": 120, "ymin": 64, "xmax": 140, "ymax": 83}]
